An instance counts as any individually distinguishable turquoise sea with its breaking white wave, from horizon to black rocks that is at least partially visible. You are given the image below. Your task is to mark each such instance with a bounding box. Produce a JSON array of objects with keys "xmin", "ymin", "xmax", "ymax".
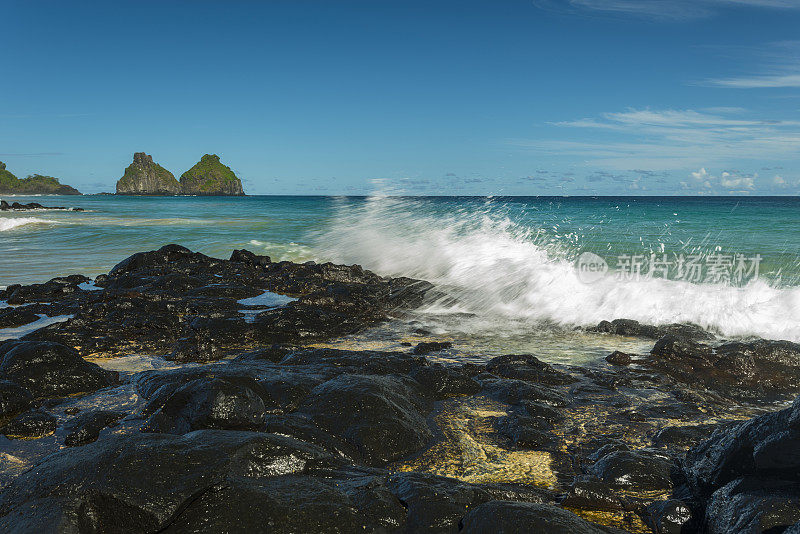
[{"xmin": 0, "ymin": 195, "xmax": 800, "ymax": 341}]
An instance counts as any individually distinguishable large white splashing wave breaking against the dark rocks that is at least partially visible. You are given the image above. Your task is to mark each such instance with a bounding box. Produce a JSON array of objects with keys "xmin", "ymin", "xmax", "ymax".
[{"xmin": 316, "ymin": 198, "xmax": 800, "ymax": 341}]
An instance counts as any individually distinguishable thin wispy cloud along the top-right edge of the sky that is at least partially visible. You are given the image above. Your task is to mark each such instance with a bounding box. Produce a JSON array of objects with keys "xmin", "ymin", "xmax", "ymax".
[{"xmin": 534, "ymin": 0, "xmax": 800, "ymax": 21}]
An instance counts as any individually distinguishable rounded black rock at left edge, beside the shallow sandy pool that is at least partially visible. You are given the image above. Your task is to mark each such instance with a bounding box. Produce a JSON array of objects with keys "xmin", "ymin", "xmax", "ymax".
[{"xmin": 0, "ymin": 341, "xmax": 119, "ymax": 397}]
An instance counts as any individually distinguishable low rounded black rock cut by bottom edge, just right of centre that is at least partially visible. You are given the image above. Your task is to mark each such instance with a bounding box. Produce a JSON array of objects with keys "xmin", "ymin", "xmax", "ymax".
[{"xmin": 461, "ymin": 501, "xmax": 604, "ymax": 534}]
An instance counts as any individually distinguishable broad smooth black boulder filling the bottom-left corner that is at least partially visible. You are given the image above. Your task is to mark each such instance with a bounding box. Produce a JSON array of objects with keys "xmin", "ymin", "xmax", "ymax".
[{"xmin": 0, "ymin": 430, "xmax": 341, "ymax": 532}]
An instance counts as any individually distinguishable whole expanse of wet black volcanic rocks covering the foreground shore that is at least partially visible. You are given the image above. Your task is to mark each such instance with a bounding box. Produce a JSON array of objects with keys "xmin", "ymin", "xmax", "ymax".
[{"xmin": 0, "ymin": 245, "xmax": 800, "ymax": 534}]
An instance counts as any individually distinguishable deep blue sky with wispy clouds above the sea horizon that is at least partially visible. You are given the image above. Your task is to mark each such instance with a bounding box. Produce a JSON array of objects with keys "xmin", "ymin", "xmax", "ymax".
[{"xmin": 0, "ymin": 0, "xmax": 800, "ymax": 195}]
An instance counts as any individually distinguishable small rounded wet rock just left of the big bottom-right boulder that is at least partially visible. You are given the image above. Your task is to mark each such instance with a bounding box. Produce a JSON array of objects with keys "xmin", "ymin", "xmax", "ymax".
[{"xmin": 591, "ymin": 450, "xmax": 673, "ymax": 492}]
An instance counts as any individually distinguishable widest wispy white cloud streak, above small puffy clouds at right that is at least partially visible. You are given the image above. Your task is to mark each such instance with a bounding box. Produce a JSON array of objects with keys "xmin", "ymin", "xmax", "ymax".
[{"xmin": 510, "ymin": 109, "xmax": 800, "ymax": 171}]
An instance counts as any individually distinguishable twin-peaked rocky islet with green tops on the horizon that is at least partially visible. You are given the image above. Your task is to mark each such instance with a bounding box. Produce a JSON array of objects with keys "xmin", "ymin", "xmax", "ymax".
[{"xmin": 117, "ymin": 152, "xmax": 244, "ymax": 196}]
